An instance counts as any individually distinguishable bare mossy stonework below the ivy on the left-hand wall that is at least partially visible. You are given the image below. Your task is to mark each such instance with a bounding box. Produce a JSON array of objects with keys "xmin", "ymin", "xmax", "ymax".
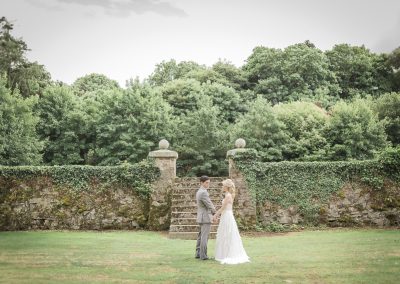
[{"xmin": 0, "ymin": 177, "xmax": 149, "ymax": 230}]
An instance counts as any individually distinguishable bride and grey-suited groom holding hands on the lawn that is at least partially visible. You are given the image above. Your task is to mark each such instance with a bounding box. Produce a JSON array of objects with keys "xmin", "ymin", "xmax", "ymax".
[{"xmin": 195, "ymin": 176, "xmax": 250, "ymax": 264}]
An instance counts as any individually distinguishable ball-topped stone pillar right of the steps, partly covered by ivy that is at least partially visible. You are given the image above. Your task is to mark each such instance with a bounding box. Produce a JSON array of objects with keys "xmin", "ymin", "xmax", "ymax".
[{"xmin": 227, "ymin": 138, "xmax": 257, "ymax": 229}]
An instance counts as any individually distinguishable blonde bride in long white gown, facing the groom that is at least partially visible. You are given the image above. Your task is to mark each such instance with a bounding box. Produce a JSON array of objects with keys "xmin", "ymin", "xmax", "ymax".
[{"xmin": 213, "ymin": 179, "xmax": 250, "ymax": 264}]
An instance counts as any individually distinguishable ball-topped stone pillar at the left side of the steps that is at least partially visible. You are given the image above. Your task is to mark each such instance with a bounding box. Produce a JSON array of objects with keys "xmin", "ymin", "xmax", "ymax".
[{"xmin": 147, "ymin": 139, "xmax": 178, "ymax": 230}]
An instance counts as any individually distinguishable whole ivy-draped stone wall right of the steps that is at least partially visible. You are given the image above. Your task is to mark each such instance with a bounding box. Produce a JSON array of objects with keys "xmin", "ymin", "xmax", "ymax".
[{"xmin": 235, "ymin": 148, "xmax": 400, "ymax": 227}]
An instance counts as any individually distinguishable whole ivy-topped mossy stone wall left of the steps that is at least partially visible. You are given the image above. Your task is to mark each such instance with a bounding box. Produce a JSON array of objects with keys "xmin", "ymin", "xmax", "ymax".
[{"xmin": 0, "ymin": 161, "xmax": 159, "ymax": 230}]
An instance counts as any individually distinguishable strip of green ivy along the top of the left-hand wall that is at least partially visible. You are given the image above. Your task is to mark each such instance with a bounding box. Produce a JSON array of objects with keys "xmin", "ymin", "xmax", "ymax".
[{"xmin": 0, "ymin": 160, "xmax": 160, "ymax": 198}]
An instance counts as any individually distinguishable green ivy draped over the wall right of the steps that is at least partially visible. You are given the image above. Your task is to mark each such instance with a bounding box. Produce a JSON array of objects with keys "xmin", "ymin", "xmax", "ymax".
[{"xmin": 233, "ymin": 148, "xmax": 400, "ymax": 223}]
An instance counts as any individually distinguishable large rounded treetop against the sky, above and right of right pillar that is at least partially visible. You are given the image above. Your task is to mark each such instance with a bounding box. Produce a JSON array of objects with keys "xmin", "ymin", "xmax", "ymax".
[{"xmin": 244, "ymin": 42, "xmax": 339, "ymax": 104}]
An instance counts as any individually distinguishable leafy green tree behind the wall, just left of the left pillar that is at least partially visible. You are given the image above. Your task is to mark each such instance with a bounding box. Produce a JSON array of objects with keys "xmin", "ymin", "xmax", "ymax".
[{"xmin": 93, "ymin": 89, "xmax": 175, "ymax": 165}]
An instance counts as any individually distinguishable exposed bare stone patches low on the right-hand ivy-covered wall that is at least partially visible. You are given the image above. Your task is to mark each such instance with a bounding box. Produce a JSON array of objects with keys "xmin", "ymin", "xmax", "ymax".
[{"xmin": 257, "ymin": 180, "xmax": 400, "ymax": 227}]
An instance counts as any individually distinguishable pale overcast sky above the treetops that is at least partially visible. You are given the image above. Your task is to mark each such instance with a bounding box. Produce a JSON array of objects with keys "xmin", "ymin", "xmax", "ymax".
[{"xmin": 0, "ymin": 0, "xmax": 400, "ymax": 86}]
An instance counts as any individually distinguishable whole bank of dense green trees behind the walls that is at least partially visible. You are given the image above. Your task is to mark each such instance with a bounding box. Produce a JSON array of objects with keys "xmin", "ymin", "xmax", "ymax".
[{"xmin": 0, "ymin": 17, "xmax": 400, "ymax": 176}]
